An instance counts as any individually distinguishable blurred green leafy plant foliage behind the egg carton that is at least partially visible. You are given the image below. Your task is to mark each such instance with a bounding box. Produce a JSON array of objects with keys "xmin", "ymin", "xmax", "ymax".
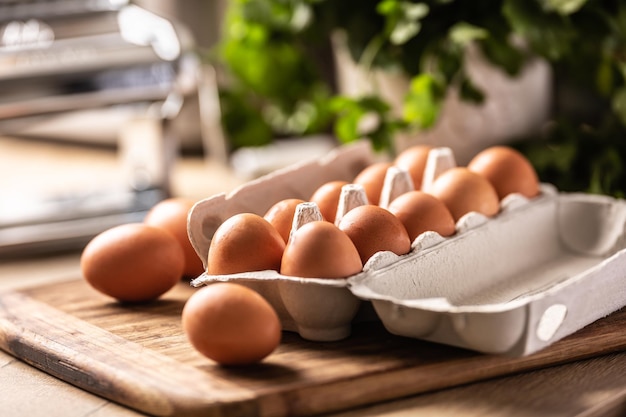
[{"xmin": 208, "ymin": 0, "xmax": 626, "ymax": 196}]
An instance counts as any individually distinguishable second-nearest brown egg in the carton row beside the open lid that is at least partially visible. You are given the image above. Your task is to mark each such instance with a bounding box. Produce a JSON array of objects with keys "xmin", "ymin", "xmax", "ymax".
[{"xmin": 338, "ymin": 204, "xmax": 411, "ymax": 264}]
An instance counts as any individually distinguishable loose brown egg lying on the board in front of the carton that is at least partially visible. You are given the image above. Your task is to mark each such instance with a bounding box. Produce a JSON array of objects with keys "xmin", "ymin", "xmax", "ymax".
[{"xmin": 182, "ymin": 282, "xmax": 281, "ymax": 365}]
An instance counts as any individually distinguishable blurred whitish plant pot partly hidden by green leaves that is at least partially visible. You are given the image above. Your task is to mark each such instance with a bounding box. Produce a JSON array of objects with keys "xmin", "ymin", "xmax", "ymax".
[{"xmin": 333, "ymin": 34, "xmax": 552, "ymax": 165}]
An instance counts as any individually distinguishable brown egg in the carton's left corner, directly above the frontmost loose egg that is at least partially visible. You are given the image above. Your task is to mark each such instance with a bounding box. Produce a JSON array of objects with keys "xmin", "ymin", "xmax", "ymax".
[{"xmin": 207, "ymin": 213, "xmax": 285, "ymax": 275}]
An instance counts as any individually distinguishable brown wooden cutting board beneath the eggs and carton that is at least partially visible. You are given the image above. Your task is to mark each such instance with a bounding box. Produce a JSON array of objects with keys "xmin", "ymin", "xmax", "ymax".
[{"xmin": 0, "ymin": 280, "xmax": 626, "ymax": 416}]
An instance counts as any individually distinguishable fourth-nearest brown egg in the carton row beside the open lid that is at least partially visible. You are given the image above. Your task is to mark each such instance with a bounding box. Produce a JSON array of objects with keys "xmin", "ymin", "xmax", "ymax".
[{"xmin": 429, "ymin": 167, "xmax": 500, "ymax": 222}]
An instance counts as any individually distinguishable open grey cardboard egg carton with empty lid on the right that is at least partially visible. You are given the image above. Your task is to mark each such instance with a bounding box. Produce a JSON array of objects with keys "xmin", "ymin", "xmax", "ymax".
[{"xmin": 188, "ymin": 142, "xmax": 626, "ymax": 356}]
